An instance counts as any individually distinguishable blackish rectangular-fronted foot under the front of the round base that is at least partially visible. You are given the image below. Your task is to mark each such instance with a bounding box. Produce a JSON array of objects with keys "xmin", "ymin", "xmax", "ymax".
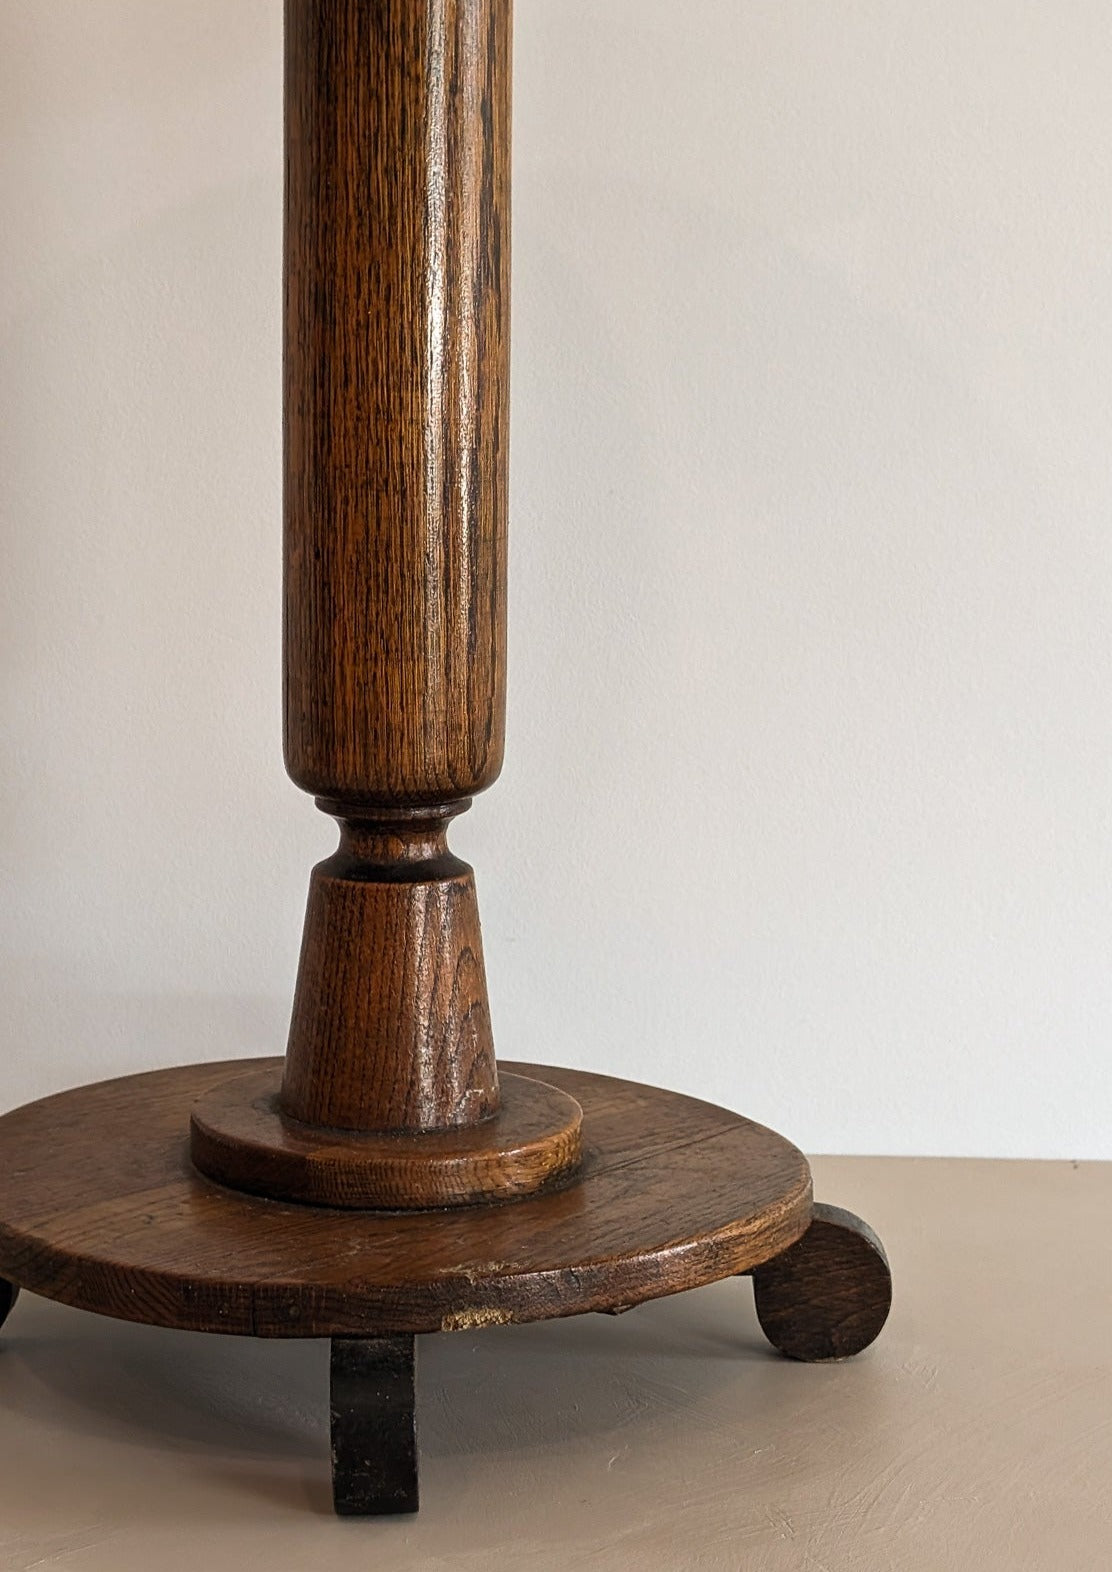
[{"xmin": 332, "ymin": 1336, "xmax": 417, "ymax": 1517}]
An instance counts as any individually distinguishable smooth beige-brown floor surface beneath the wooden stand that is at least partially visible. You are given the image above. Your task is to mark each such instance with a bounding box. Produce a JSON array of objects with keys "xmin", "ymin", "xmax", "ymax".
[{"xmin": 0, "ymin": 1159, "xmax": 1112, "ymax": 1572}]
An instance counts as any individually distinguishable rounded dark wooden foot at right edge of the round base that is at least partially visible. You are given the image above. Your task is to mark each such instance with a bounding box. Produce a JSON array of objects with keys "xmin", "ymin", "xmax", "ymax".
[{"xmin": 753, "ymin": 1206, "xmax": 892, "ymax": 1360}]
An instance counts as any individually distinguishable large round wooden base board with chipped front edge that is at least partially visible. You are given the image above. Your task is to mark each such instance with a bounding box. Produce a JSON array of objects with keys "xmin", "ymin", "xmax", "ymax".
[{"xmin": 0, "ymin": 1060, "xmax": 812, "ymax": 1338}]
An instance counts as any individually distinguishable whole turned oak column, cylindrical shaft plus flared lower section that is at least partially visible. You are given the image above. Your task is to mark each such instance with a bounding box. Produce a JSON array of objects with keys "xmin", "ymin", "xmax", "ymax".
[{"xmin": 282, "ymin": 0, "xmax": 510, "ymax": 1130}]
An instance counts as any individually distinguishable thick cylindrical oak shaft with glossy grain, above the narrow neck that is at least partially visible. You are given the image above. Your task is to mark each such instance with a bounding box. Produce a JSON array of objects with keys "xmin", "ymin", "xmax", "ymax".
[{"xmin": 285, "ymin": 0, "xmax": 511, "ymax": 808}]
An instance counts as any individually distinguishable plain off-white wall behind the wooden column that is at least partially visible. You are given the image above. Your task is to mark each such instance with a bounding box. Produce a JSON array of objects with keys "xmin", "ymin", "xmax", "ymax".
[{"xmin": 0, "ymin": 0, "xmax": 1112, "ymax": 1157}]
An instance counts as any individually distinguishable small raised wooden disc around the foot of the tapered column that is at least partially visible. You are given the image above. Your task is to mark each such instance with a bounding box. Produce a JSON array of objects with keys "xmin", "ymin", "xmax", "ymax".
[{"xmin": 190, "ymin": 1064, "xmax": 582, "ymax": 1207}]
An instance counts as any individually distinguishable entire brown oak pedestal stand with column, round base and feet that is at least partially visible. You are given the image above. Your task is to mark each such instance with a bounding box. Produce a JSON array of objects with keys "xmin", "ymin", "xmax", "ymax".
[{"xmin": 0, "ymin": 0, "xmax": 890, "ymax": 1512}]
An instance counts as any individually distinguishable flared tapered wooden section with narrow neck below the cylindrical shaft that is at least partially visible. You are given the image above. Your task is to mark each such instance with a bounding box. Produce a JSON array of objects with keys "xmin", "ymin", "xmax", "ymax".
[{"xmin": 282, "ymin": 813, "xmax": 499, "ymax": 1130}]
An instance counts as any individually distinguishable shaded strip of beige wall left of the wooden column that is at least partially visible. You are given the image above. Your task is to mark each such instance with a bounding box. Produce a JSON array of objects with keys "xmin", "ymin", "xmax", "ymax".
[{"xmin": 0, "ymin": 0, "xmax": 312, "ymax": 1105}]
